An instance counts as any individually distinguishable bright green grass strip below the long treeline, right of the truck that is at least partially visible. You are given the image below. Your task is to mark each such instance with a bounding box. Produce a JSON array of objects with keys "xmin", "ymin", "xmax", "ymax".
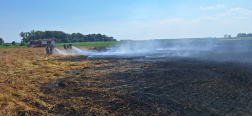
[{"xmin": 56, "ymin": 41, "xmax": 120, "ymax": 47}]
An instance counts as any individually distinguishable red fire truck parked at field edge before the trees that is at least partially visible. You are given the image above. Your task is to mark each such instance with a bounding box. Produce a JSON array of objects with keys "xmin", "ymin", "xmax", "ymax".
[{"xmin": 27, "ymin": 39, "xmax": 56, "ymax": 48}]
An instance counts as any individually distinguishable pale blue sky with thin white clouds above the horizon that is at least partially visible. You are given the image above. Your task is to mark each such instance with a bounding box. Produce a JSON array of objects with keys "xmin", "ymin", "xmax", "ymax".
[{"xmin": 0, "ymin": 0, "xmax": 252, "ymax": 42}]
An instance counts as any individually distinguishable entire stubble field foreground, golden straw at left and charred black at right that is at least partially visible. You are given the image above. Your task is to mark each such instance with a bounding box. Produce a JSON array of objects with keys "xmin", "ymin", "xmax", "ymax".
[{"xmin": 0, "ymin": 42, "xmax": 252, "ymax": 115}]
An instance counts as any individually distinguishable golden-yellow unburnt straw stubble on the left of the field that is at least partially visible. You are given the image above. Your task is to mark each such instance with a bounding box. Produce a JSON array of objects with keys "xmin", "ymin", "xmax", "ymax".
[{"xmin": 0, "ymin": 48, "xmax": 97, "ymax": 115}]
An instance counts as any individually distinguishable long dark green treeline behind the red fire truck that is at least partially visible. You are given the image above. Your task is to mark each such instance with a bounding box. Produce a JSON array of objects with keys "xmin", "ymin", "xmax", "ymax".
[{"xmin": 19, "ymin": 30, "xmax": 116, "ymax": 43}]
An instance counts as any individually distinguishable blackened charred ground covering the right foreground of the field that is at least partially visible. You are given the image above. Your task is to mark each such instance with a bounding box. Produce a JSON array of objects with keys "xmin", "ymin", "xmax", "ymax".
[{"xmin": 42, "ymin": 58, "xmax": 252, "ymax": 115}]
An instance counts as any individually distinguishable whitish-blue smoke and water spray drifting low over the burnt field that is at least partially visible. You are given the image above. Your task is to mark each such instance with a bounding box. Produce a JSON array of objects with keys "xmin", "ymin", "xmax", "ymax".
[{"xmin": 56, "ymin": 39, "xmax": 252, "ymax": 62}]
